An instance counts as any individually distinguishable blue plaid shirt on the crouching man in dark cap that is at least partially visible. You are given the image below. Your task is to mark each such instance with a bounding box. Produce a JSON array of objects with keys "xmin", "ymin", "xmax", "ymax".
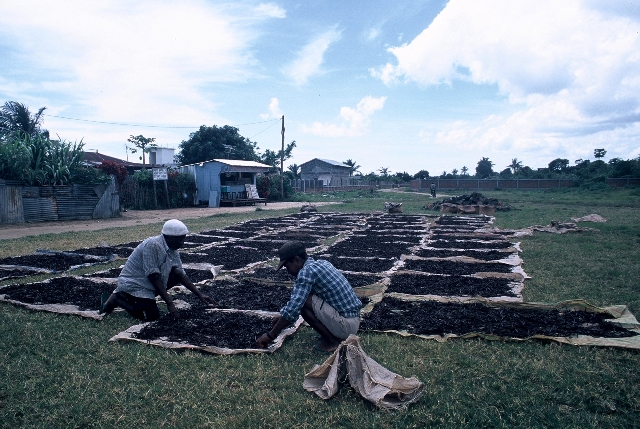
[{"xmin": 280, "ymin": 257, "xmax": 362, "ymax": 322}]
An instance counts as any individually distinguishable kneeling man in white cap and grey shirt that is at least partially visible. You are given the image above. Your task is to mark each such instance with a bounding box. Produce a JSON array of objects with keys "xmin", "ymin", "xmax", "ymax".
[{"xmin": 100, "ymin": 219, "xmax": 216, "ymax": 321}]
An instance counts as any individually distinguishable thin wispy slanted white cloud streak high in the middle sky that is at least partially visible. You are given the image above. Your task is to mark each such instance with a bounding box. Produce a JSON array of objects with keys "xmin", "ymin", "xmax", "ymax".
[{"xmin": 282, "ymin": 28, "xmax": 342, "ymax": 85}]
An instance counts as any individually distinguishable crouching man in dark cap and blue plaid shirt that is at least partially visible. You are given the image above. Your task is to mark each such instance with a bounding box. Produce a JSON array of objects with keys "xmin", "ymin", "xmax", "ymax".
[{"xmin": 257, "ymin": 241, "xmax": 362, "ymax": 352}]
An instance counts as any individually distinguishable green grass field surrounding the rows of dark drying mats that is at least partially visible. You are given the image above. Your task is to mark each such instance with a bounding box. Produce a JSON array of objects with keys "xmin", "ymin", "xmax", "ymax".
[{"xmin": 0, "ymin": 189, "xmax": 640, "ymax": 428}]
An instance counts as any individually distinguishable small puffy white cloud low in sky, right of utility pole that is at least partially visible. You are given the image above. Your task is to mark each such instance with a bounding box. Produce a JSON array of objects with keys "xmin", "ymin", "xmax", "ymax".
[{"xmin": 302, "ymin": 96, "xmax": 387, "ymax": 137}]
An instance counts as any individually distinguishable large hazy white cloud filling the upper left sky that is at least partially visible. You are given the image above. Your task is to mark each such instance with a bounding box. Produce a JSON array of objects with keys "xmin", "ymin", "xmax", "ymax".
[{"xmin": 0, "ymin": 0, "xmax": 276, "ymax": 134}]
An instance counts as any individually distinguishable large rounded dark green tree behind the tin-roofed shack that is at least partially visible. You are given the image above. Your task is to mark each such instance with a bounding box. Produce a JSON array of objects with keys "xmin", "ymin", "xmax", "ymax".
[{"xmin": 175, "ymin": 125, "xmax": 260, "ymax": 165}]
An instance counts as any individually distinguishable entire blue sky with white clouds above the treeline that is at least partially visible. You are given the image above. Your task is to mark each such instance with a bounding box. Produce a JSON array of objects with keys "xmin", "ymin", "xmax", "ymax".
[{"xmin": 0, "ymin": 0, "xmax": 640, "ymax": 176}]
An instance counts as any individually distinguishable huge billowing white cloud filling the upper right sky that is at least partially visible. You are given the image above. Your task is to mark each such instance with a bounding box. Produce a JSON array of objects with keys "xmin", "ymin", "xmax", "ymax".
[{"xmin": 371, "ymin": 0, "xmax": 640, "ymax": 165}]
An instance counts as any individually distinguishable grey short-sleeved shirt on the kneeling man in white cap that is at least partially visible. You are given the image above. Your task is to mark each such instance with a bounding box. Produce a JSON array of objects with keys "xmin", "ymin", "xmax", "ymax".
[{"xmin": 115, "ymin": 234, "xmax": 184, "ymax": 299}]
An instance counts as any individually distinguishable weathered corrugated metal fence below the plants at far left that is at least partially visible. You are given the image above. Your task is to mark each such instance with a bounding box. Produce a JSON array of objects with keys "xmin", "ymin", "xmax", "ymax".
[{"xmin": 0, "ymin": 178, "xmax": 120, "ymax": 223}]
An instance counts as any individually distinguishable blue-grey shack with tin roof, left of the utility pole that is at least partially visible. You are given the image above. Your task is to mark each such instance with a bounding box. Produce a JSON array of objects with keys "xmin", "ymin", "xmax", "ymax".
[{"xmin": 179, "ymin": 159, "xmax": 271, "ymax": 207}]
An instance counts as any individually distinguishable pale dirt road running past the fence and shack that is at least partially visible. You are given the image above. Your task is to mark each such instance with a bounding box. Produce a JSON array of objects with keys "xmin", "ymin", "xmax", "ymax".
[{"xmin": 0, "ymin": 202, "xmax": 336, "ymax": 240}]
